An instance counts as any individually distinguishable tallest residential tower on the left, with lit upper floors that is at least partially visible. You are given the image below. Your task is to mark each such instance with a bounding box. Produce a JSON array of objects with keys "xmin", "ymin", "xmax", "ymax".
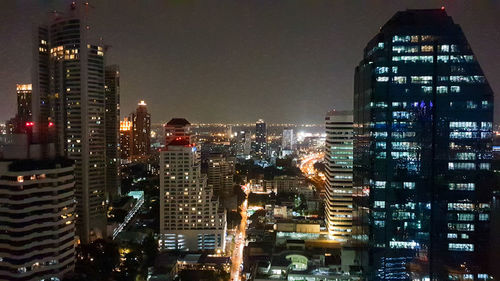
[{"xmin": 32, "ymin": 2, "xmax": 106, "ymax": 243}]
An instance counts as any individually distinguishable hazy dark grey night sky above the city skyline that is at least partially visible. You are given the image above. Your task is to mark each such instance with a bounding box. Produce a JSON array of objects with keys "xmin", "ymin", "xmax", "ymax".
[{"xmin": 0, "ymin": 0, "xmax": 500, "ymax": 123}]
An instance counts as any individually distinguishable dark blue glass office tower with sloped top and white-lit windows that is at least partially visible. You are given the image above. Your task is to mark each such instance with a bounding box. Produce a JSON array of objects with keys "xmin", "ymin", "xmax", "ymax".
[{"xmin": 354, "ymin": 9, "xmax": 498, "ymax": 280}]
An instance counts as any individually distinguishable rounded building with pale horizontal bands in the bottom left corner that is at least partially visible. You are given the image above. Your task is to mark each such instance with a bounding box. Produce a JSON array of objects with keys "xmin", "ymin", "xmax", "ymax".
[{"xmin": 0, "ymin": 134, "xmax": 76, "ymax": 281}]
